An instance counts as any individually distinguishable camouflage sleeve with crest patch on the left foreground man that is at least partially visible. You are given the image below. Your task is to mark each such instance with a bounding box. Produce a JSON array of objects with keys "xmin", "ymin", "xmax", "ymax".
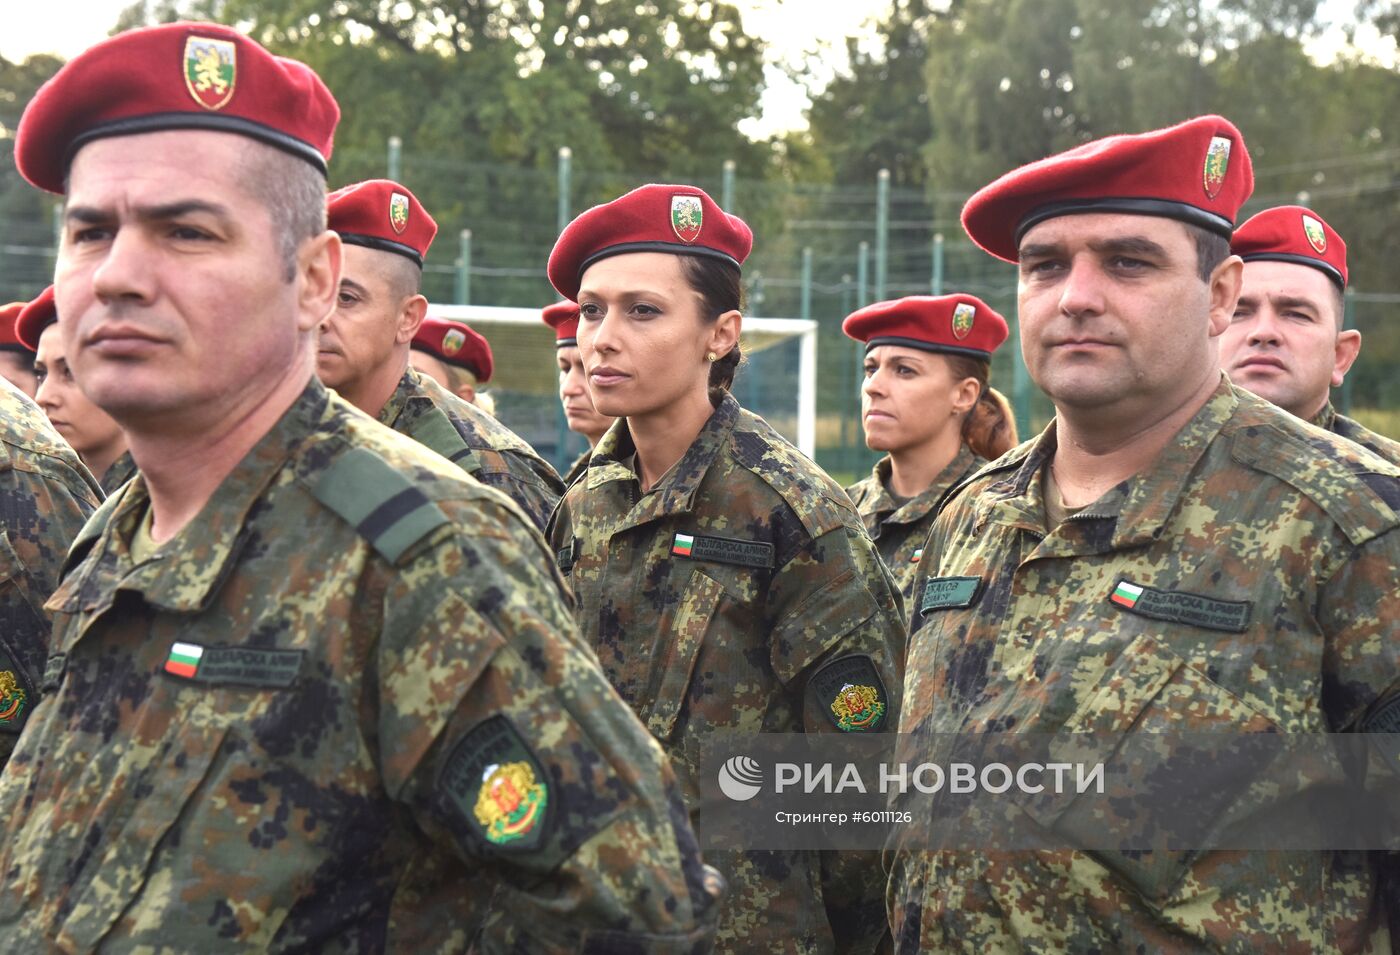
[{"xmin": 377, "ymin": 501, "xmax": 720, "ymax": 954}]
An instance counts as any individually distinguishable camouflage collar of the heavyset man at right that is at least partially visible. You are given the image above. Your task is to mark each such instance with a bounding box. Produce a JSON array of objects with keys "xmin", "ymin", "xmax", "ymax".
[{"xmin": 976, "ymin": 375, "xmax": 1239, "ymax": 546}]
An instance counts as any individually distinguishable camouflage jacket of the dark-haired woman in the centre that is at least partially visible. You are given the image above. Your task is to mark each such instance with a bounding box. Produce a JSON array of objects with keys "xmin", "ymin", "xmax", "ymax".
[{"xmin": 550, "ymin": 396, "xmax": 904, "ymax": 952}]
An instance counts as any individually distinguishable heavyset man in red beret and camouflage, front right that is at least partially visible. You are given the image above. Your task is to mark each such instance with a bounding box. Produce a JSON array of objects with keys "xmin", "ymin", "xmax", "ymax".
[{"xmin": 889, "ymin": 116, "xmax": 1400, "ymax": 955}]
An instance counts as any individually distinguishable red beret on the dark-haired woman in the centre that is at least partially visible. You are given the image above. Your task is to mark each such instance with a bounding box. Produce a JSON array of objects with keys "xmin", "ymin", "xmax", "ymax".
[{"xmin": 549, "ymin": 183, "xmax": 753, "ymax": 300}]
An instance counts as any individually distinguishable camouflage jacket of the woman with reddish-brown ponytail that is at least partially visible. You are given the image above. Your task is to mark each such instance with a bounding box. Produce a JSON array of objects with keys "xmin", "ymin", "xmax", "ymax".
[{"xmin": 846, "ymin": 444, "xmax": 987, "ymax": 608}]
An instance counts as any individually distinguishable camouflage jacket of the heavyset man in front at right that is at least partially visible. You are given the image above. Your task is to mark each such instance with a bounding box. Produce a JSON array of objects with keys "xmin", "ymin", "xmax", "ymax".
[{"xmin": 889, "ymin": 379, "xmax": 1400, "ymax": 955}]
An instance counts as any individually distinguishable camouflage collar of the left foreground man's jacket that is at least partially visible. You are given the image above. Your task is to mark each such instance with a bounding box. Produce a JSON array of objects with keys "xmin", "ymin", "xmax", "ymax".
[{"xmin": 49, "ymin": 377, "xmax": 333, "ymax": 613}]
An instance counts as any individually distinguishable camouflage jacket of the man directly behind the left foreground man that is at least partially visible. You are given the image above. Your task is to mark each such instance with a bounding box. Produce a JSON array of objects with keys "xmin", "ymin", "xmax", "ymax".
[{"xmin": 379, "ymin": 368, "xmax": 564, "ymax": 531}]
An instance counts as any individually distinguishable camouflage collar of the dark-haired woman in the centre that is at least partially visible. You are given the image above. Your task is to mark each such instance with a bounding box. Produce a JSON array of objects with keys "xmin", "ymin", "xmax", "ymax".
[{"xmin": 588, "ymin": 395, "xmax": 739, "ymax": 525}]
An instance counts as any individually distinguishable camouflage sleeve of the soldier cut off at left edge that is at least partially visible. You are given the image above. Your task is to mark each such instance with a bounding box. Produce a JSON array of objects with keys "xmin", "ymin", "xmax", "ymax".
[{"xmin": 0, "ymin": 450, "xmax": 98, "ymax": 766}]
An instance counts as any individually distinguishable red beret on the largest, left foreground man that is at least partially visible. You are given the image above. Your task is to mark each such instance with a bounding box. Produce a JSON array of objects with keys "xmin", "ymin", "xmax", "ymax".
[{"xmin": 14, "ymin": 22, "xmax": 340, "ymax": 192}]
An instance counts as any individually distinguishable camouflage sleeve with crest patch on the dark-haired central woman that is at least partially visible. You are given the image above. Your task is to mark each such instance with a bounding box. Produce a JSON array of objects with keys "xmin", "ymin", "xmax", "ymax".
[{"xmin": 773, "ymin": 525, "xmax": 904, "ymax": 952}]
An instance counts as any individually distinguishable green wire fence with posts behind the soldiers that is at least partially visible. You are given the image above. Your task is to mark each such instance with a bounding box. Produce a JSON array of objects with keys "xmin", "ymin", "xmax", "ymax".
[{"xmin": 0, "ymin": 140, "xmax": 1400, "ymax": 480}]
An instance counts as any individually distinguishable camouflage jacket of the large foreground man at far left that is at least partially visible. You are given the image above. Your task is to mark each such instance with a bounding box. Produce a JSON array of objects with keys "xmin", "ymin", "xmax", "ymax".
[{"xmin": 0, "ymin": 379, "xmax": 718, "ymax": 954}]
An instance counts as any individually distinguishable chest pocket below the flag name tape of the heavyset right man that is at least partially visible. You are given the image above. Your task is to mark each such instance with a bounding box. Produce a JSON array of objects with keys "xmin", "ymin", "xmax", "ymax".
[{"xmin": 1022, "ymin": 634, "xmax": 1280, "ymax": 903}]
